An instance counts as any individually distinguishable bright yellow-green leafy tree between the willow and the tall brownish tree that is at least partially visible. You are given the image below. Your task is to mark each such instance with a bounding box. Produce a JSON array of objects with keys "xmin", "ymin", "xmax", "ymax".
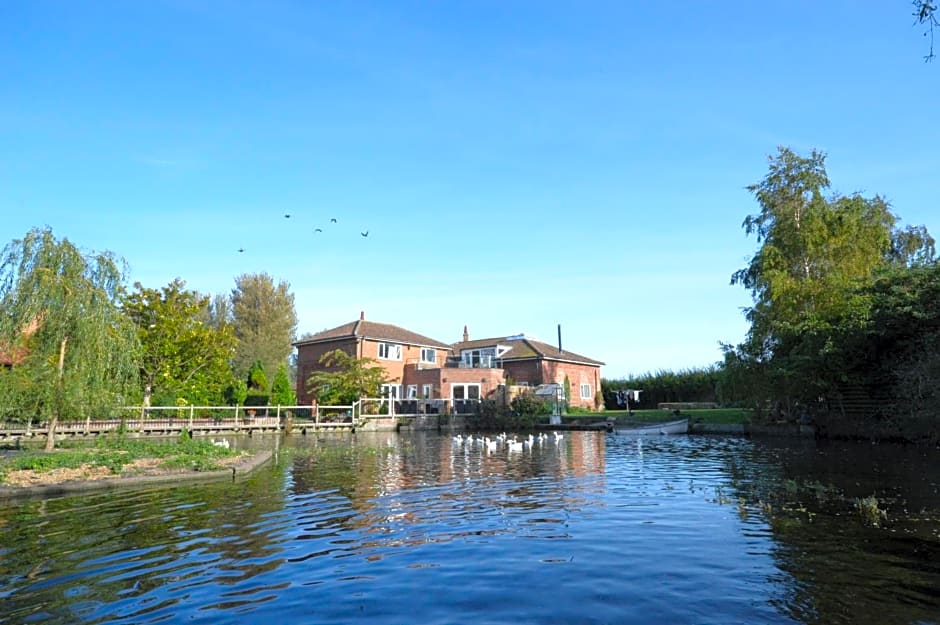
[{"xmin": 123, "ymin": 278, "xmax": 236, "ymax": 405}]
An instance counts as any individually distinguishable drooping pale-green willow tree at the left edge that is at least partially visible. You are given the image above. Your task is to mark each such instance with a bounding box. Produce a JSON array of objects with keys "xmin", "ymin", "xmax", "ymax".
[{"xmin": 0, "ymin": 228, "xmax": 139, "ymax": 449}]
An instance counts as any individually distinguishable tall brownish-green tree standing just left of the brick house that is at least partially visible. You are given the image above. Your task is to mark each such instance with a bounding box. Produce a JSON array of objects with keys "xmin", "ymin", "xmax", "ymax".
[{"xmin": 231, "ymin": 273, "xmax": 297, "ymax": 380}]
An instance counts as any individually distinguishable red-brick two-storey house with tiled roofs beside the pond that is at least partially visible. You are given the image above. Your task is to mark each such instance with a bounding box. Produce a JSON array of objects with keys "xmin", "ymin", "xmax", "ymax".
[{"xmin": 294, "ymin": 315, "xmax": 603, "ymax": 408}]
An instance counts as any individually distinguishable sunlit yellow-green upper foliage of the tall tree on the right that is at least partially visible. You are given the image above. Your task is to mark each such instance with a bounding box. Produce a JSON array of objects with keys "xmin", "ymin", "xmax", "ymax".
[{"xmin": 731, "ymin": 148, "xmax": 896, "ymax": 350}]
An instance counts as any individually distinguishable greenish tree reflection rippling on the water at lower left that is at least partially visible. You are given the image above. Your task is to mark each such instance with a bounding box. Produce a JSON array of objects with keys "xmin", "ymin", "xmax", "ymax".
[{"xmin": 0, "ymin": 465, "xmax": 283, "ymax": 623}]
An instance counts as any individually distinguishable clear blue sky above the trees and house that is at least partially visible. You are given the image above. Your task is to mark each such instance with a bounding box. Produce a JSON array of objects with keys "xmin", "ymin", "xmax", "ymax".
[{"xmin": 0, "ymin": 0, "xmax": 940, "ymax": 378}]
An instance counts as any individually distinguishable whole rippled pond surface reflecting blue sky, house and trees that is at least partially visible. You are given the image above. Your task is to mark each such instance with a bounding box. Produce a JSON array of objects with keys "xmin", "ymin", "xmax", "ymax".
[{"xmin": 0, "ymin": 432, "xmax": 940, "ymax": 624}]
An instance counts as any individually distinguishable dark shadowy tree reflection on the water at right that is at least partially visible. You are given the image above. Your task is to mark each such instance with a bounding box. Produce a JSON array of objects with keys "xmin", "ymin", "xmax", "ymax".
[{"xmin": 724, "ymin": 440, "xmax": 940, "ymax": 625}]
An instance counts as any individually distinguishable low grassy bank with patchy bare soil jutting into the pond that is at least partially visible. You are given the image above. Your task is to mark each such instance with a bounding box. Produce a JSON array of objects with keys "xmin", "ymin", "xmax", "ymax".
[{"xmin": 0, "ymin": 435, "xmax": 239, "ymax": 484}]
